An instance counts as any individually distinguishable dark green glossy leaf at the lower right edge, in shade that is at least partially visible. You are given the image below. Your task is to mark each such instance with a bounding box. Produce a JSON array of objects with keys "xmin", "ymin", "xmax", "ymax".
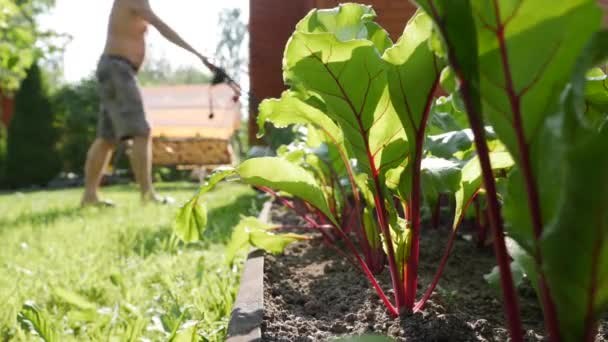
[{"xmin": 504, "ymin": 28, "xmax": 608, "ymax": 341}]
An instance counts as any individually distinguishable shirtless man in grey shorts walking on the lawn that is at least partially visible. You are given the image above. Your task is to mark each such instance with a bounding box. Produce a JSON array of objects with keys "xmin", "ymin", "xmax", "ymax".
[{"xmin": 81, "ymin": 0, "xmax": 215, "ymax": 206}]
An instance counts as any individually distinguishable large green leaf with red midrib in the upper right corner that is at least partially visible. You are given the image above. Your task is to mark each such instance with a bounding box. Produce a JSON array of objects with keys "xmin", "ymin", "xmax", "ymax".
[{"xmin": 472, "ymin": 0, "xmax": 600, "ymax": 160}]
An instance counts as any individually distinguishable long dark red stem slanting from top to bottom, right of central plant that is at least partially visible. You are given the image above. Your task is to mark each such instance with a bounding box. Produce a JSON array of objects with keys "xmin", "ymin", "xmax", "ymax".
[{"xmin": 429, "ymin": 0, "xmax": 524, "ymax": 336}]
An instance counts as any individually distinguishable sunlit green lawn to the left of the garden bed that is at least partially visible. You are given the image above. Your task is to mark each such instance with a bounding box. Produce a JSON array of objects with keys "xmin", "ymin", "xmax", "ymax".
[{"xmin": 0, "ymin": 183, "xmax": 259, "ymax": 341}]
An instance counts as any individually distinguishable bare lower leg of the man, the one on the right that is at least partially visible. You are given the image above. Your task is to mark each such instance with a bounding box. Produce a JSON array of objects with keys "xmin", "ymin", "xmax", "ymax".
[{"xmin": 130, "ymin": 135, "xmax": 159, "ymax": 201}]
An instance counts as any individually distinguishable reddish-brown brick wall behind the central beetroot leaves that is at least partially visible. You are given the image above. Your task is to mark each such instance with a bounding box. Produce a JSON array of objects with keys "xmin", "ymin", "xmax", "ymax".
[{"xmin": 249, "ymin": 0, "xmax": 416, "ymax": 145}]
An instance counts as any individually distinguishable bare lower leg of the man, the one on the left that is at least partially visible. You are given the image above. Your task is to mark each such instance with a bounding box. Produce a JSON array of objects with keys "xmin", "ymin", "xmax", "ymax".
[{"xmin": 81, "ymin": 138, "xmax": 114, "ymax": 206}]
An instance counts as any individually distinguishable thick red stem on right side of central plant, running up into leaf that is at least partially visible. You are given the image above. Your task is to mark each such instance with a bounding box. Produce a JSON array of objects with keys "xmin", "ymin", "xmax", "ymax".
[{"xmin": 404, "ymin": 67, "xmax": 439, "ymax": 311}]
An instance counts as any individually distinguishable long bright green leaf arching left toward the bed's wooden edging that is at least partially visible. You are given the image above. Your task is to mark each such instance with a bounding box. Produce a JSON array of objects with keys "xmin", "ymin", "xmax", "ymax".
[{"xmin": 237, "ymin": 157, "xmax": 337, "ymax": 223}]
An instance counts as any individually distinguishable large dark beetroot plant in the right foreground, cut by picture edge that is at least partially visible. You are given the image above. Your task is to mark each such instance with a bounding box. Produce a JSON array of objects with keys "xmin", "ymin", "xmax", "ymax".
[{"xmin": 419, "ymin": 0, "xmax": 608, "ymax": 341}]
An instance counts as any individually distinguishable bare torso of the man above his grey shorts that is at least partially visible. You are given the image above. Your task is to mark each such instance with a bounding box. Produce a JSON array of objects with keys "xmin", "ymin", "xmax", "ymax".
[{"xmin": 104, "ymin": 0, "xmax": 148, "ymax": 68}]
